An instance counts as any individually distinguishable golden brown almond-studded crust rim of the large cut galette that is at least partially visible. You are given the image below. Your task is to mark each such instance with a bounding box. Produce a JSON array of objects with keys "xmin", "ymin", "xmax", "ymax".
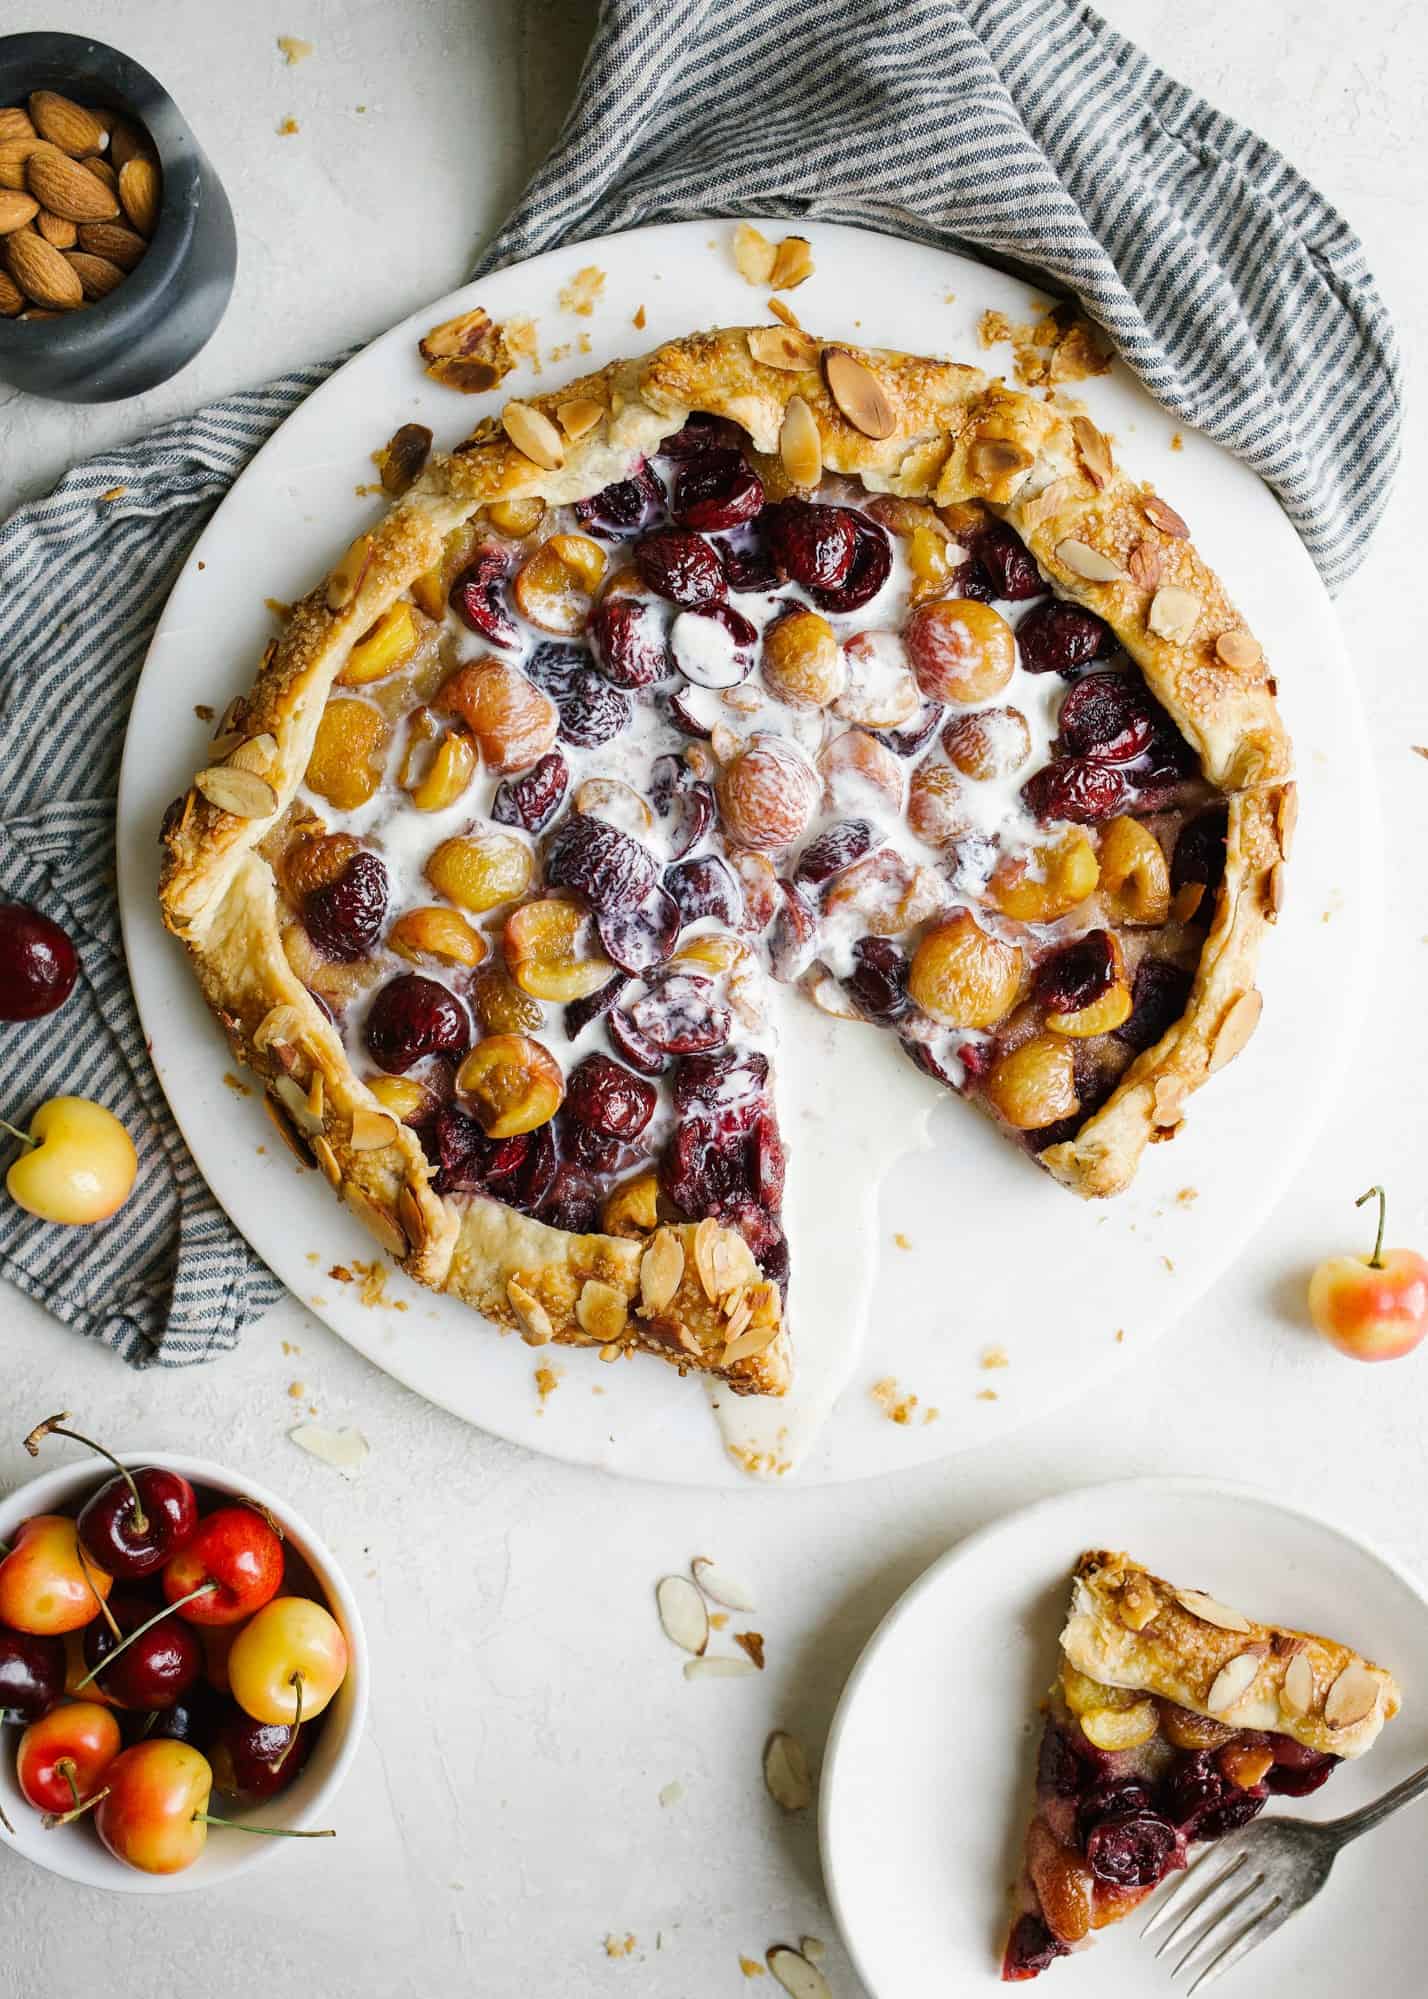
[{"xmin": 160, "ymin": 328, "xmax": 1294, "ymax": 1393}]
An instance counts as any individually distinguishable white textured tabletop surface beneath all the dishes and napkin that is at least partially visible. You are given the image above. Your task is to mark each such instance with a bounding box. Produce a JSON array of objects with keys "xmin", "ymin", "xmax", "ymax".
[{"xmin": 0, "ymin": 0, "xmax": 1428, "ymax": 1999}]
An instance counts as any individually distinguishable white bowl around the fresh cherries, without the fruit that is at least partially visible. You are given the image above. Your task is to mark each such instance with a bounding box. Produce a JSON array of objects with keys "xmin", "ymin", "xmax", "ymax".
[{"xmin": 0, "ymin": 1451, "xmax": 368, "ymax": 1895}]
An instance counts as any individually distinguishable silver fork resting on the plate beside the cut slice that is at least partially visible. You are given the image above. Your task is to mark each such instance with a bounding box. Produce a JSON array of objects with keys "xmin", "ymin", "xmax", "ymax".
[{"xmin": 1140, "ymin": 1765, "xmax": 1428, "ymax": 1993}]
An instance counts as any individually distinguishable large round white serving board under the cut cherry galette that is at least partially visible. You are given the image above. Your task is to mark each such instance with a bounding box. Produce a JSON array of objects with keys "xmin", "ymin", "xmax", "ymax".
[{"xmin": 118, "ymin": 222, "xmax": 1378, "ymax": 1483}]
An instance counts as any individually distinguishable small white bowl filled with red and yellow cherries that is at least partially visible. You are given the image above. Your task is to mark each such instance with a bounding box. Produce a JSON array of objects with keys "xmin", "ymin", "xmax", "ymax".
[{"xmin": 0, "ymin": 1417, "xmax": 368, "ymax": 1893}]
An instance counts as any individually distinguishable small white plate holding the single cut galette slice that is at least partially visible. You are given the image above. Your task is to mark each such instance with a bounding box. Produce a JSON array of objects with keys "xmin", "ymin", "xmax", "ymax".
[{"xmin": 820, "ymin": 1479, "xmax": 1428, "ymax": 1999}]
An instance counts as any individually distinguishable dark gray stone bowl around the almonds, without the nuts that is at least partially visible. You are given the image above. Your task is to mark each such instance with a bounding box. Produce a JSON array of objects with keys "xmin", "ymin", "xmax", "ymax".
[{"xmin": 0, "ymin": 34, "xmax": 238, "ymax": 402}]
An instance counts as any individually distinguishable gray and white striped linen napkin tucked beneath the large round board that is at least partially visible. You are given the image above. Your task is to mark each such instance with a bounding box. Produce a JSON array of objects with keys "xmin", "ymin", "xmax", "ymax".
[{"xmin": 0, "ymin": 0, "xmax": 1402, "ymax": 1365}]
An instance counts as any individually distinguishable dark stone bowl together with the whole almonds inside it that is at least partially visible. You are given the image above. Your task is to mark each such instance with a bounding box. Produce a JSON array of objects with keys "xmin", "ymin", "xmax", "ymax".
[{"xmin": 0, "ymin": 34, "xmax": 238, "ymax": 402}]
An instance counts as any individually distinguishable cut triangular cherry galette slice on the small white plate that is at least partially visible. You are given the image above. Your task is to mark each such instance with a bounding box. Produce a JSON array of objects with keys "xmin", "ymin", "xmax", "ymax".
[{"xmin": 1002, "ymin": 1551, "xmax": 1400, "ymax": 1983}]
